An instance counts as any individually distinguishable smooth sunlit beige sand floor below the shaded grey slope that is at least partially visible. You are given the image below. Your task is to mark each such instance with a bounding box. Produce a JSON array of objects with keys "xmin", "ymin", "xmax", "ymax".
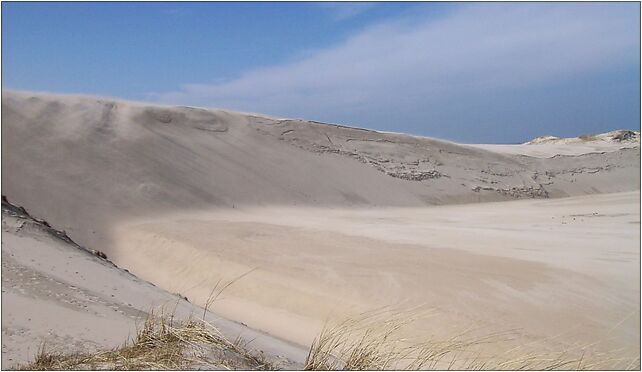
[{"xmin": 114, "ymin": 192, "xmax": 640, "ymax": 358}]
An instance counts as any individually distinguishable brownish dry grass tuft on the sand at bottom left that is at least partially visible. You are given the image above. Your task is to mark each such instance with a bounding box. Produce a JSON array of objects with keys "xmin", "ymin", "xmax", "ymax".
[{"xmin": 18, "ymin": 313, "xmax": 274, "ymax": 370}]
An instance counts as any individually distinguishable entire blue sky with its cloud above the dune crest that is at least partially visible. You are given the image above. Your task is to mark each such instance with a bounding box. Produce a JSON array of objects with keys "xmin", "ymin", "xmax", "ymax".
[{"xmin": 2, "ymin": 2, "xmax": 640, "ymax": 143}]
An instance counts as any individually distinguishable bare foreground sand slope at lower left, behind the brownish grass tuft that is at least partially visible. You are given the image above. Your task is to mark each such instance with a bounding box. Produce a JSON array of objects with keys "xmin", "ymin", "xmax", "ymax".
[{"xmin": 2, "ymin": 208, "xmax": 306, "ymax": 370}]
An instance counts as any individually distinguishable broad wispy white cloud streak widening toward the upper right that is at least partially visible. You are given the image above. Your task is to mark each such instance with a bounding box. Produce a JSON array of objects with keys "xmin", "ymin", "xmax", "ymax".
[{"xmin": 151, "ymin": 3, "xmax": 640, "ymax": 140}]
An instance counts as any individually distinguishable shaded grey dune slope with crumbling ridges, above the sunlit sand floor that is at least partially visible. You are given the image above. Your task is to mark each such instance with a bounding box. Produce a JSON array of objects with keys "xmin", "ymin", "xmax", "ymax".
[{"xmin": 2, "ymin": 92, "xmax": 640, "ymax": 252}]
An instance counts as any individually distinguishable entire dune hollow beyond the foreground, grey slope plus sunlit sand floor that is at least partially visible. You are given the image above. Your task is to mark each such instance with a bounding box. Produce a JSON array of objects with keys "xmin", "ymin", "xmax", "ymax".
[{"xmin": 2, "ymin": 92, "xmax": 640, "ymax": 366}]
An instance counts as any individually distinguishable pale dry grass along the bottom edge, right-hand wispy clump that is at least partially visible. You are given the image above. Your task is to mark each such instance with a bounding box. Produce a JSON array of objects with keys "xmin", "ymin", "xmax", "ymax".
[{"xmin": 304, "ymin": 312, "xmax": 640, "ymax": 370}]
